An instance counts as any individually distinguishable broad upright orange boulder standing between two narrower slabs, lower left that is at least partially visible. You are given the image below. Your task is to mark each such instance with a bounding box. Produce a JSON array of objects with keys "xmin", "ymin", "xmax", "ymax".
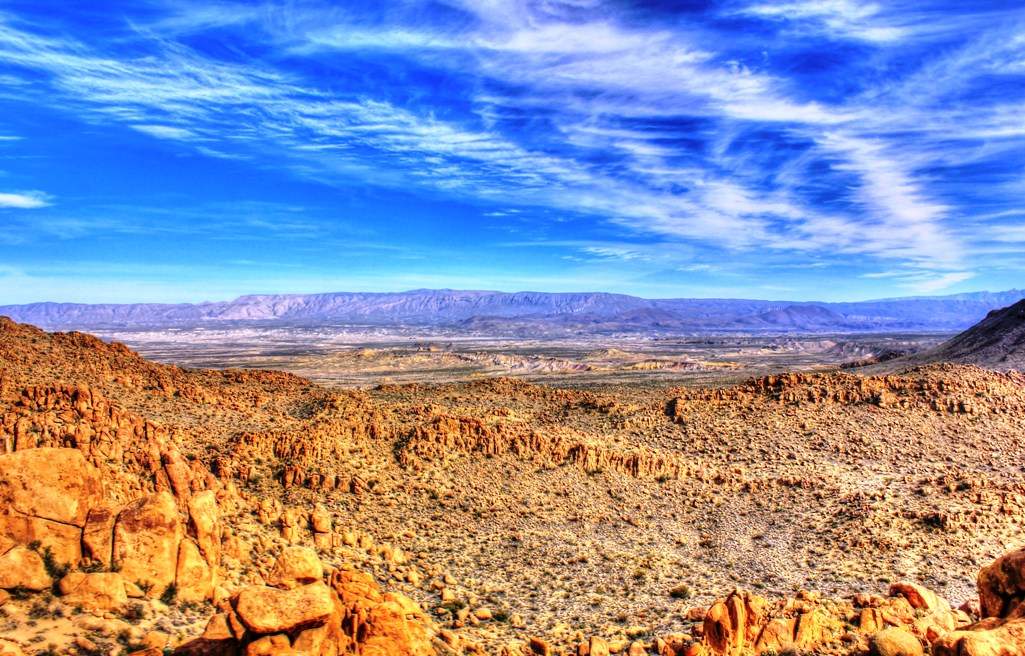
[{"xmin": 114, "ymin": 492, "xmax": 181, "ymax": 597}]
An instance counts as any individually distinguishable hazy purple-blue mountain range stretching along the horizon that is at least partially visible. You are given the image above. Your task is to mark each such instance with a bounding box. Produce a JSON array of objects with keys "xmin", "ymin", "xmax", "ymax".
[{"xmin": 0, "ymin": 289, "xmax": 1025, "ymax": 334}]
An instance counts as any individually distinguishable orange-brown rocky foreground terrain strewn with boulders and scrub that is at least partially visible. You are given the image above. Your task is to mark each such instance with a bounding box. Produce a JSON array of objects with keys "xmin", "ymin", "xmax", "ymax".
[{"xmin": 0, "ymin": 320, "xmax": 1025, "ymax": 656}]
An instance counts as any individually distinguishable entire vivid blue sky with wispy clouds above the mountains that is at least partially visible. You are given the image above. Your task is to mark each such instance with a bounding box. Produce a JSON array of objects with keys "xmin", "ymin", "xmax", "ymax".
[{"xmin": 0, "ymin": 0, "xmax": 1025, "ymax": 302}]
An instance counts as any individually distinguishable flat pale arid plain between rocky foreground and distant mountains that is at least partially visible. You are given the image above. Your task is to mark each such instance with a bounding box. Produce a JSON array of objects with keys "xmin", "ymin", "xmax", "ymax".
[{"xmin": 90, "ymin": 326, "xmax": 950, "ymax": 387}]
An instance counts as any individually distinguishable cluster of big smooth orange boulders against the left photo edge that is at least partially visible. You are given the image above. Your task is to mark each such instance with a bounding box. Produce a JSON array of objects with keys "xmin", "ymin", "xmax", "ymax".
[{"xmin": 0, "ymin": 447, "xmax": 221, "ymax": 612}]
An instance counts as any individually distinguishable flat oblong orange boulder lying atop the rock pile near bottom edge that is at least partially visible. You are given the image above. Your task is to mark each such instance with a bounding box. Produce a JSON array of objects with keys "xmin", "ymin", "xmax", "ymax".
[{"xmin": 235, "ymin": 581, "xmax": 334, "ymax": 634}]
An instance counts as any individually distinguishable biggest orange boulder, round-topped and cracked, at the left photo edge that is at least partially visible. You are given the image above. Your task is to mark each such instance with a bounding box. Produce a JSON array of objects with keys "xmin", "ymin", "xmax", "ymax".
[{"xmin": 0, "ymin": 448, "xmax": 103, "ymax": 564}]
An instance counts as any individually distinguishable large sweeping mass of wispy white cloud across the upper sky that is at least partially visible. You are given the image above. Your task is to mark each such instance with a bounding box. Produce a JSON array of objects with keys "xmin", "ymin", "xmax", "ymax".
[{"xmin": 0, "ymin": 0, "xmax": 1025, "ymax": 295}]
